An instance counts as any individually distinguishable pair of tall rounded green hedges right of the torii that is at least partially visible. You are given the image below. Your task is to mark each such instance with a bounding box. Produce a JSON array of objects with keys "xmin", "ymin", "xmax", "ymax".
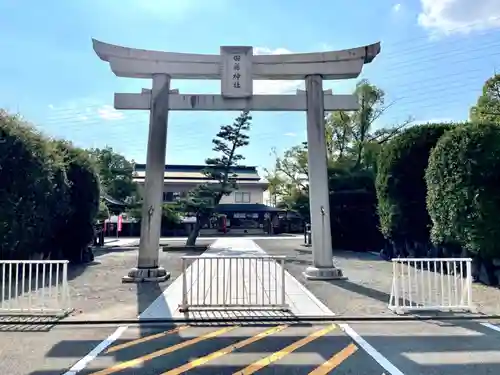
[{"xmin": 376, "ymin": 123, "xmax": 500, "ymax": 257}]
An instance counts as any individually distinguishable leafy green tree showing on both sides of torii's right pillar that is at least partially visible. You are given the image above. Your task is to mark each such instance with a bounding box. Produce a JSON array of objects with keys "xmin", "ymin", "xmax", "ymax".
[{"xmin": 266, "ymin": 80, "xmax": 412, "ymax": 206}]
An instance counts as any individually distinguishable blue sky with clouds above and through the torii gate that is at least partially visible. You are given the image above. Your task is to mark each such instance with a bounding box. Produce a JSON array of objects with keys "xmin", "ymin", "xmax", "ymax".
[{"xmin": 0, "ymin": 0, "xmax": 500, "ymax": 171}]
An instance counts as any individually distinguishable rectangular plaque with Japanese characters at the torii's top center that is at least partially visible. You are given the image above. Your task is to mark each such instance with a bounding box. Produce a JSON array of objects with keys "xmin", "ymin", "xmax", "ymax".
[{"xmin": 220, "ymin": 47, "xmax": 253, "ymax": 98}]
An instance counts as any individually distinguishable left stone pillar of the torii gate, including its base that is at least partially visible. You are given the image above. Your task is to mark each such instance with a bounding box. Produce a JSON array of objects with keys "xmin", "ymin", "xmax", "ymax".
[{"xmin": 122, "ymin": 74, "xmax": 170, "ymax": 282}]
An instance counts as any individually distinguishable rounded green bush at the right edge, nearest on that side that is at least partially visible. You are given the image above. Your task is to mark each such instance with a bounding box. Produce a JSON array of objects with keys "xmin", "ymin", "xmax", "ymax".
[{"xmin": 425, "ymin": 124, "xmax": 500, "ymax": 257}]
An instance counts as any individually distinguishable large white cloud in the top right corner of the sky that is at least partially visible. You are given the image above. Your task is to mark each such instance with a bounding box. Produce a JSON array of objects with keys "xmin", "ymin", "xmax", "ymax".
[{"xmin": 418, "ymin": 0, "xmax": 500, "ymax": 35}]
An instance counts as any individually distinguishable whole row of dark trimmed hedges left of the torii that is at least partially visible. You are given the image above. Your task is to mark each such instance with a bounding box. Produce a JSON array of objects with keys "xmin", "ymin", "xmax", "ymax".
[{"xmin": 0, "ymin": 111, "xmax": 100, "ymax": 261}]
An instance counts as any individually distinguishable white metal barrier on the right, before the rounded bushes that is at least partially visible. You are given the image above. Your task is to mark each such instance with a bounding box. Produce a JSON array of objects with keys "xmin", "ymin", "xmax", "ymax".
[{"xmin": 389, "ymin": 258, "xmax": 475, "ymax": 314}]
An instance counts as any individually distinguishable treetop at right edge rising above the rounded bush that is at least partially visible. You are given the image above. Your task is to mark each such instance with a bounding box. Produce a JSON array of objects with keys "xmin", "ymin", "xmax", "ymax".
[{"xmin": 470, "ymin": 74, "xmax": 500, "ymax": 124}]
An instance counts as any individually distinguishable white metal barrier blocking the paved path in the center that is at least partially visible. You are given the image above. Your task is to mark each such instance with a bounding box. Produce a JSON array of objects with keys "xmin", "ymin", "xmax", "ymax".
[{"xmin": 179, "ymin": 255, "xmax": 288, "ymax": 312}]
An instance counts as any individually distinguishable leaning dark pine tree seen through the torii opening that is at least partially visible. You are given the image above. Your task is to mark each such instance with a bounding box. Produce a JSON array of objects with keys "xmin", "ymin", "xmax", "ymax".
[{"xmin": 181, "ymin": 111, "xmax": 252, "ymax": 246}]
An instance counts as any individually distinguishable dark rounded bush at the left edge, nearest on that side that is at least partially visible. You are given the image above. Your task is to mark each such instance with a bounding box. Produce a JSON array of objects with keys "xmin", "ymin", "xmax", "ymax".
[{"xmin": 0, "ymin": 110, "xmax": 68, "ymax": 259}]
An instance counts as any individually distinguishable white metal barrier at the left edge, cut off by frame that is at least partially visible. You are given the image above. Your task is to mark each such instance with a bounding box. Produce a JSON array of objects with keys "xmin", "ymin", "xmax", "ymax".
[{"xmin": 0, "ymin": 260, "xmax": 70, "ymax": 316}]
